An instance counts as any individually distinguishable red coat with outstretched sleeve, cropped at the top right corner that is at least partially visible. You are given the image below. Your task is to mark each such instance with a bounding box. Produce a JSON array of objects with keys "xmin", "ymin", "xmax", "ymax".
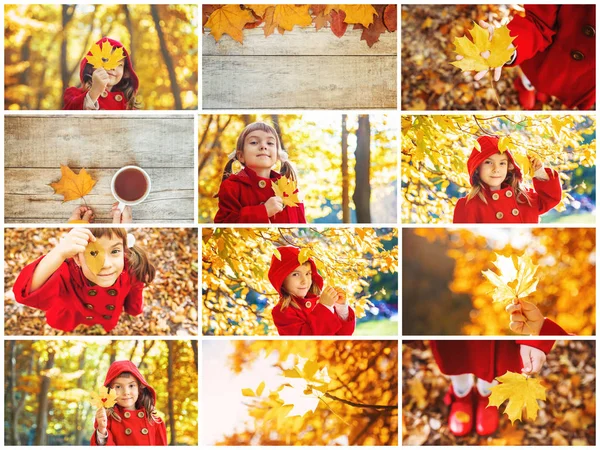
[{"xmin": 508, "ymin": 5, "xmax": 596, "ymax": 109}]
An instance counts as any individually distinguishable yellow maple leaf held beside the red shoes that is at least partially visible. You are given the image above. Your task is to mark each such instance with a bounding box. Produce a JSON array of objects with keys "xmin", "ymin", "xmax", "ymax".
[{"xmin": 488, "ymin": 371, "xmax": 546, "ymax": 424}]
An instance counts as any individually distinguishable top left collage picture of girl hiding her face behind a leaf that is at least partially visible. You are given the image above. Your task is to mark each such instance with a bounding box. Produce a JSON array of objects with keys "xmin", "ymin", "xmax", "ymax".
[{"xmin": 4, "ymin": 4, "xmax": 198, "ymax": 110}]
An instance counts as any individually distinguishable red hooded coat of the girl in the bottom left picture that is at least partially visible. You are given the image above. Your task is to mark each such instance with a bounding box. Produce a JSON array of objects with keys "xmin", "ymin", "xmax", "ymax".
[{"xmin": 90, "ymin": 361, "xmax": 167, "ymax": 446}]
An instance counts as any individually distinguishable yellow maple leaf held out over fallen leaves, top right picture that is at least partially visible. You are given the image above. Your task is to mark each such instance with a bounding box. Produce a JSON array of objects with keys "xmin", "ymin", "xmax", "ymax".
[{"xmin": 451, "ymin": 22, "xmax": 515, "ymax": 72}]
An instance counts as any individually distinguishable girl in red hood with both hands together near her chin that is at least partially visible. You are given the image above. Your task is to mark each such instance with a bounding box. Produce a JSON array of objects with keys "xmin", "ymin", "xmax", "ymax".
[{"xmin": 269, "ymin": 246, "xmax": 356, "ymax": 336}]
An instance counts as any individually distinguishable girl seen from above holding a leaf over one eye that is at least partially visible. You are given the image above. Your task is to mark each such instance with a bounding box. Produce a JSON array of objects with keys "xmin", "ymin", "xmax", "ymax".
[{"xmin": 13, "ymin": 228, "xmax": 155, "ymax": 332}]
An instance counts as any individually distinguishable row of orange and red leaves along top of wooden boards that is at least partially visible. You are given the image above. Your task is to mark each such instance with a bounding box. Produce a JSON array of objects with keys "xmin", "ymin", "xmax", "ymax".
[{"xmin": 202, "ymin": 4, "xmax": 397, "ymax": 47}]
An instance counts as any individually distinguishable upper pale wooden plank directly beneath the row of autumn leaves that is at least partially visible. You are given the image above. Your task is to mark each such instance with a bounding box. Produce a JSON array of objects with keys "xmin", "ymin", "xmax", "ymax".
[{"xmin": 202, "ymin": 25, "xmax": 398, "ymax": 56}]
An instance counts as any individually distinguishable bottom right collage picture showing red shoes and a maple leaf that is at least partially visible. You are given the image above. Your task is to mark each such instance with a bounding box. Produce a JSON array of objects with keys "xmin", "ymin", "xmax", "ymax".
[{"xmin": 402, "ymin": 340, "xmax": 596, "ymax": 447}]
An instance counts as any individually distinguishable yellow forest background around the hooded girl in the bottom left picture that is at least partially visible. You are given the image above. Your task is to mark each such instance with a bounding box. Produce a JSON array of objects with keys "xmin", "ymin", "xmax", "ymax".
[{"xmin": 4, "ymin": 340, "xmax": 198, "ymax": 445}]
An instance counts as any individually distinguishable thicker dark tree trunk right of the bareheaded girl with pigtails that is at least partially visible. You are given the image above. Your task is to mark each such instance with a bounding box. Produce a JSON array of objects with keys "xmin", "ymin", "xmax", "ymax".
[{"xmin": 352, "ymin": 115, "xmax": 371, "ymax": 223}]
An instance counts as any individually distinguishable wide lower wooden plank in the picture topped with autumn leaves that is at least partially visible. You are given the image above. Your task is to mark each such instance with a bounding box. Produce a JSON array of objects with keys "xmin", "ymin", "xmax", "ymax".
[{"xmin": 202, "ymin": 56, "xmax": 397, "ymax": 109}]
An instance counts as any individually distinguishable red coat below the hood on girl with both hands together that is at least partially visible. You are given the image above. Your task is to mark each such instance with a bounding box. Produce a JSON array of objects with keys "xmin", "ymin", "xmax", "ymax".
[{"xmin": 272, "ymin": 294, "xmax": 356, "ymax": 336}]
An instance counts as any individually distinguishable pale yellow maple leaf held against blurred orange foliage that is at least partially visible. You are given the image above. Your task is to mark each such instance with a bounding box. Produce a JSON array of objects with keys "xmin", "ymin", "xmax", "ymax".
[{"xmin": 481, "ymin": 253, "xmax": 539, "ymax": 303}]
